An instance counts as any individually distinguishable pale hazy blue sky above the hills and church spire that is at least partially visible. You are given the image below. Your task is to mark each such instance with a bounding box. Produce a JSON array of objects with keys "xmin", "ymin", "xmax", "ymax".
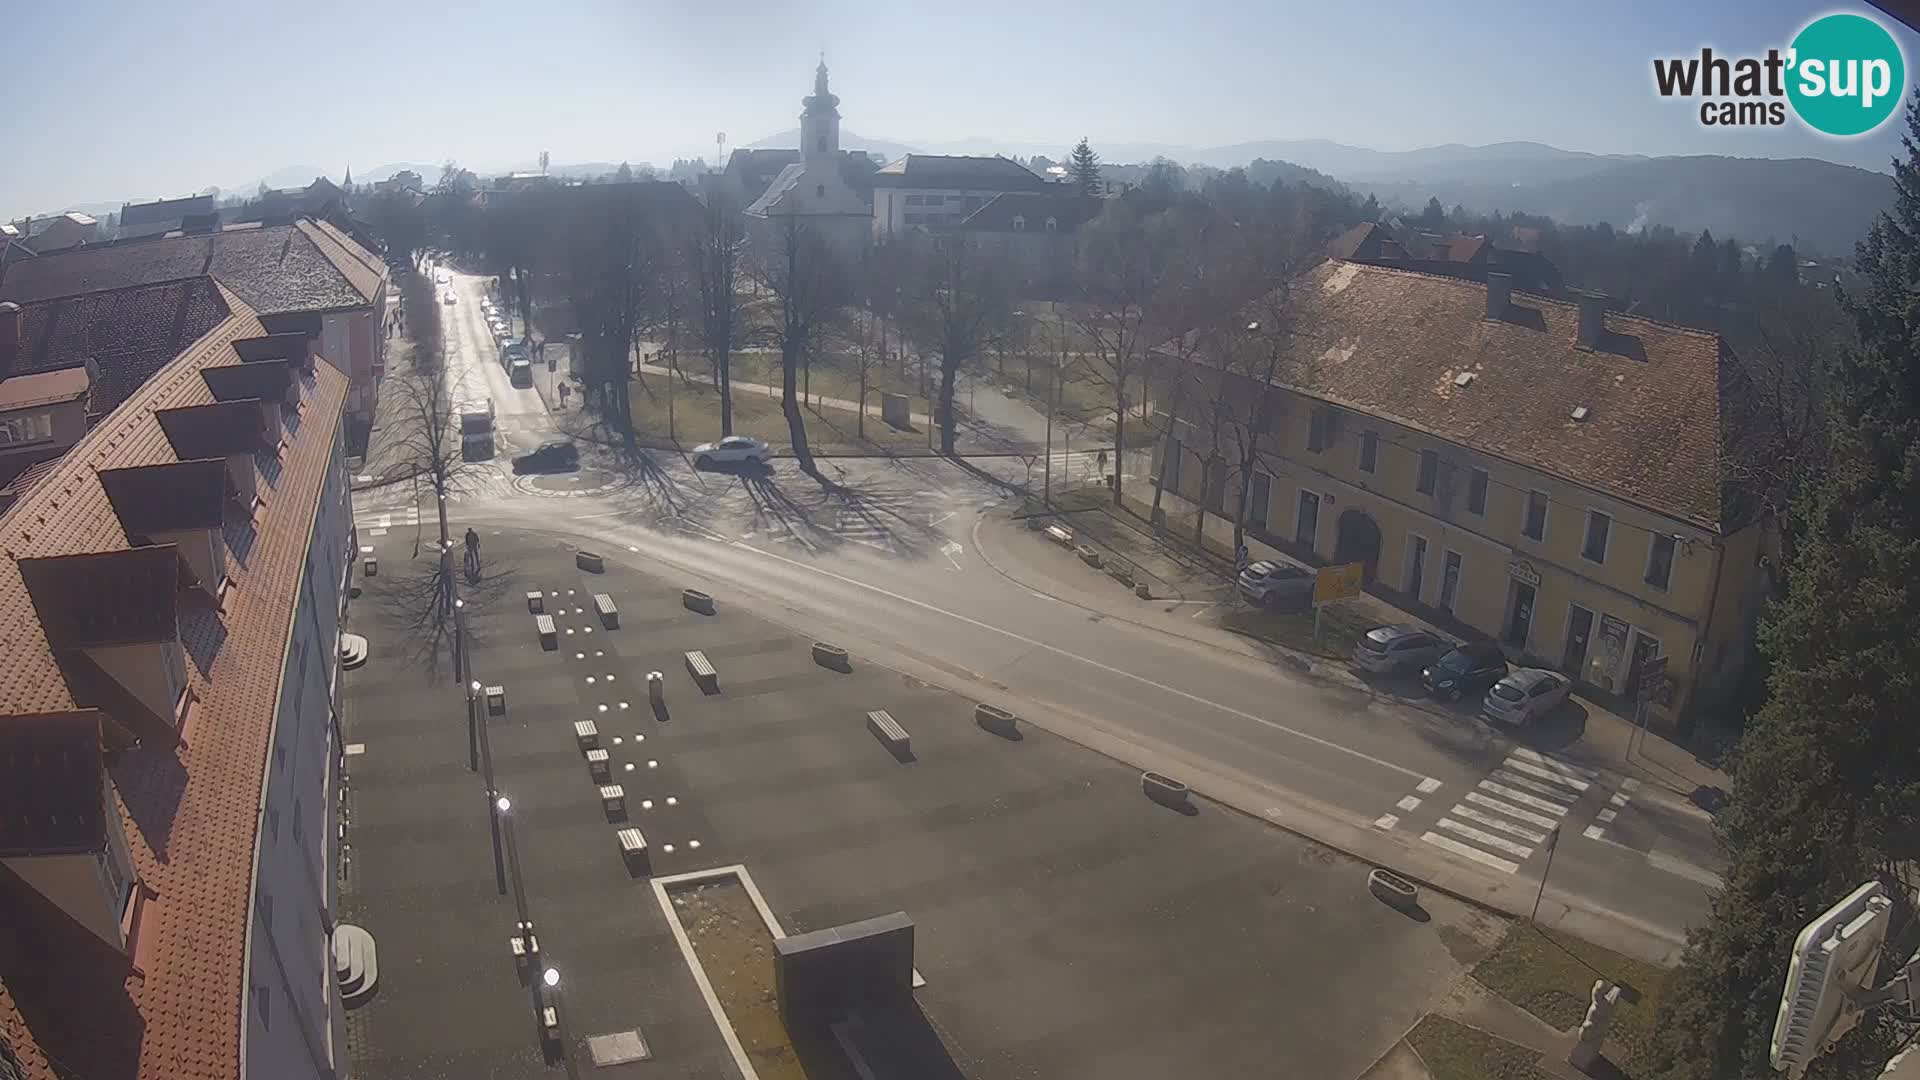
[{"xmin": 0, "ymin": 0, "xmax": 1920, "ymax": 217}]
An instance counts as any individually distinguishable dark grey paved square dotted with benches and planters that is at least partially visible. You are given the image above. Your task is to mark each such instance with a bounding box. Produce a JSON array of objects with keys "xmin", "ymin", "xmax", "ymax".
[{"xmin": 348, "ymin": 527, "xmax": 1500, "ymax": 1080}]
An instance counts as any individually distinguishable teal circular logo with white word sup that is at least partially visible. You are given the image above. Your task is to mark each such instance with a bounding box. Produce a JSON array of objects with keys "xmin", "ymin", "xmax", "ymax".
[{"xmin": 1788, "ymin": 15, "xmax": 1907, "ymax": 135}]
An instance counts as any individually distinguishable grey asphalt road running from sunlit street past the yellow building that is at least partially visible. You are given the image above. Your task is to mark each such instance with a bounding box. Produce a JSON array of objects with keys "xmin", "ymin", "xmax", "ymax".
[{"xmin": 355, "ymin": 265, "xmax": 1718, "ymax": 942}]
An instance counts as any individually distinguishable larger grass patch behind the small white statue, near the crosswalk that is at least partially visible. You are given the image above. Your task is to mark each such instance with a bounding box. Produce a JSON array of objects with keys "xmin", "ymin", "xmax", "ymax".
[{"xmin": 1473, "ymin": 922, "xmax": 1667, "ymax": 1070}]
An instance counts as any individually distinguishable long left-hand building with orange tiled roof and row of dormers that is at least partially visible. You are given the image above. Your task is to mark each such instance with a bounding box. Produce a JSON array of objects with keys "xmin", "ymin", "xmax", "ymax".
[{"xmin": 0, "ymin": 284, "xmax": 353, "ymax": 1080}]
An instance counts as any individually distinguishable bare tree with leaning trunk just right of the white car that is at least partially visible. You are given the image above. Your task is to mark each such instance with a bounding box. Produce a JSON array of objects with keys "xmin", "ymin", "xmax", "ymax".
[{"xmin": 753, "ymin": 215, "xmax": 852, "ymax": 479}]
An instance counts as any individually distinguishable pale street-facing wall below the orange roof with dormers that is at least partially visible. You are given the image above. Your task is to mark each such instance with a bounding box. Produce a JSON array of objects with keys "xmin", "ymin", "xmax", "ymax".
[{"xmin": 244, "ymin": 413, "xmax": 351, "ymax": 1080}]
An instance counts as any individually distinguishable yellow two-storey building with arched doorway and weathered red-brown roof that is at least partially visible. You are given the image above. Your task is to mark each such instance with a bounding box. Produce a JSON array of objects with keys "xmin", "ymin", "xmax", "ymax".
[{"xmin": 1129, "ymin": 259, "xmax": 1764, "ymax": 719}]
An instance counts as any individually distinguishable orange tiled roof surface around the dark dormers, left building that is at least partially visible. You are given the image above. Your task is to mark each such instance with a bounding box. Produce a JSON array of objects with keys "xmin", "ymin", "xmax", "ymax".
[{"xmin": 0, "ymin": 282, "xmax": 348, "ymax": 1080}]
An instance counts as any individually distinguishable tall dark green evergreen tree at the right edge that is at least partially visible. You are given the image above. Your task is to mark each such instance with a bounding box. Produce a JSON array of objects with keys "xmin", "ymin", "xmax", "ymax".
[{"xmin": 1647, "ymin": 96, "xmax": 1920, "ymax": 1080}]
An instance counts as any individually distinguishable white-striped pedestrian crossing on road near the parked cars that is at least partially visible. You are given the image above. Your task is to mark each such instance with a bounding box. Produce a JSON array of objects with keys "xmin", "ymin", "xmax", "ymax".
[{"xmin": 1421, "ymin": 748, "xmax": 1597, "ymax": 874}]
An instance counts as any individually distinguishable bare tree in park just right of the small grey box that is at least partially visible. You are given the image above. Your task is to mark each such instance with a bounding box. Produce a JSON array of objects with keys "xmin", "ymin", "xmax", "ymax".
[{"xmin": 902, "ymin": 231, "xmax": 1012, "ymax": 455}]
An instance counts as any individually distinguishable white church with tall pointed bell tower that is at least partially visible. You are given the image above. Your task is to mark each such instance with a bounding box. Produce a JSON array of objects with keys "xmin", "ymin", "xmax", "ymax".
[{"xmin": 730, "ymin": 60, "xmax": 874, "ymax": 256}]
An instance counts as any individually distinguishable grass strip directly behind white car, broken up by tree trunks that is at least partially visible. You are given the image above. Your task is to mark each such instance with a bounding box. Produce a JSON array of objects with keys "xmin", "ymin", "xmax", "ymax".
[{"xmin": 628, "ymin": 375, "xmax": 939, "ymax": 455}]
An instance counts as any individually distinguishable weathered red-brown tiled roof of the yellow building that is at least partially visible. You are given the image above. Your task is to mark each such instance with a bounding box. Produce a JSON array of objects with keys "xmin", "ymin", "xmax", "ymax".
[{"xmin": 1277, "ymin": 259, "xmax": 1730, "ymax": 528}]
